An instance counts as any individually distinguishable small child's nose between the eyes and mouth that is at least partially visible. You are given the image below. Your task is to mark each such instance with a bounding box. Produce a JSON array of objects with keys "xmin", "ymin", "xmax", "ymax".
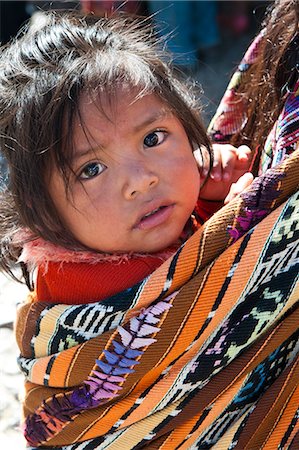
[{"xmin": 123, "ymin": 164, "xmax": 159, "ymax": 200}]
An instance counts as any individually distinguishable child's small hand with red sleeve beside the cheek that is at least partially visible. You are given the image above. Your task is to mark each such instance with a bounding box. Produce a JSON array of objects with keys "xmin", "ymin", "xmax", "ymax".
[{"xmin": 194, "ymin": 144, "xmax": 251, "ymax": 201}]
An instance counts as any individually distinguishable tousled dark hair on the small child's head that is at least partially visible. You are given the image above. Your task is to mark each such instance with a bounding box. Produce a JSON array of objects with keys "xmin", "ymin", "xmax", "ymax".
[{"xmin": 0, "ymin": 11, "xmax": 211, "ymax": 280}]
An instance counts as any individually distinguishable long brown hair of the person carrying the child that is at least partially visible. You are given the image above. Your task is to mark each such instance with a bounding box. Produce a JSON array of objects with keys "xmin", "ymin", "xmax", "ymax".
[{"xmin": 231, "ymin": 0, "xmax": 299, "ymax": 172}]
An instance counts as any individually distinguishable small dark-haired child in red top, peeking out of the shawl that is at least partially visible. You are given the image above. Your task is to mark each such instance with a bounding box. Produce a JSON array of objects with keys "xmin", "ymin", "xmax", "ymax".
[{"xmin": 0, "ymin": 12, "xmax": 252, "ymax": 304}]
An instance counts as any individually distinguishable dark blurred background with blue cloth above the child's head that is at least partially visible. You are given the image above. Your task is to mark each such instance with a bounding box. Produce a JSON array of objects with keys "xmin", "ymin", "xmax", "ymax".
[{"xmin": 0, "ymin": 0, "xmax": 271, "ymax": 122}]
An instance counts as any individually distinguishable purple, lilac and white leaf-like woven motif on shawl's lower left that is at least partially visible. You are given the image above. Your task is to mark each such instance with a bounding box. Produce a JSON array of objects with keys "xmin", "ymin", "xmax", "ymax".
[{"xmin": 25, "ymin": 297, "xmax": 176, "ymax": 445}]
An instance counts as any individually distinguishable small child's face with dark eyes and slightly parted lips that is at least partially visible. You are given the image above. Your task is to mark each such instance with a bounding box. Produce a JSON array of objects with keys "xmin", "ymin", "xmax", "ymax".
[{"xmin": 49, "ymin": 92, "xmax": 200, "ymax": 253}]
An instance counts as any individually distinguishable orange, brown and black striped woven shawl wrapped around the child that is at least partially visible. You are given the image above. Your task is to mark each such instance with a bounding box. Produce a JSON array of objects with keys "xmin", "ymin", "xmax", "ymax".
[{"xmin": 17, "ymin": 36, "xmax": 299, "ymax": 450}]
